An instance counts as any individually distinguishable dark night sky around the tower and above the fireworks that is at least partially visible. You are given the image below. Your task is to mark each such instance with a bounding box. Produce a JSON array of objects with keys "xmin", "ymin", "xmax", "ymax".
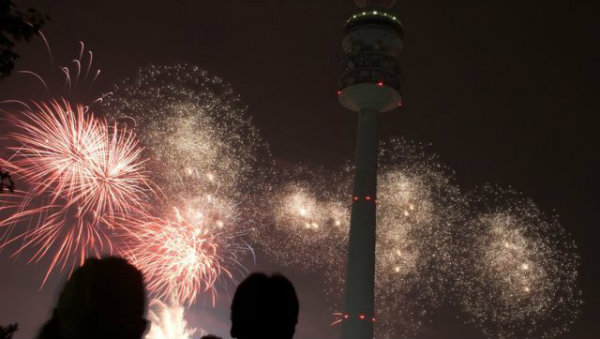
[{"xmin": 0, "ymin": 0, "xmax": 600, "ymax": 338}]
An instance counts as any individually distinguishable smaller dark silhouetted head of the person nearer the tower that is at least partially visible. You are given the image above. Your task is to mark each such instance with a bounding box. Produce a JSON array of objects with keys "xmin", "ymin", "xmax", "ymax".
[{"xmin": 230, "ymin": 273, "xmax": 299, "ymax": 339}]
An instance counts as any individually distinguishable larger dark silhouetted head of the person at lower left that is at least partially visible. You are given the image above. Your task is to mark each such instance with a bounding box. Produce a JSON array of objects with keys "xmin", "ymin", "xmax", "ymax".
[{"xmin": 39, "ymin": 257, "xmax": 148, "ymax": 339}]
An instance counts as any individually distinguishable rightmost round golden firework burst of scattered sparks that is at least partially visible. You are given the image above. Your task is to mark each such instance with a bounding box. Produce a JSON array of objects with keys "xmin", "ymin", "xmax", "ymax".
[{"xmin": 456, "ymin": 186, "xmax": 582, "ymax": 338}]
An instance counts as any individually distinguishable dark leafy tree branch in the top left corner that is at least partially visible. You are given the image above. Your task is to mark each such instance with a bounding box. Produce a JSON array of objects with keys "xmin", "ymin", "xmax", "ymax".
[{"xmin": 0, "ymin": 0, "xmax": 48, "ymax": 79}]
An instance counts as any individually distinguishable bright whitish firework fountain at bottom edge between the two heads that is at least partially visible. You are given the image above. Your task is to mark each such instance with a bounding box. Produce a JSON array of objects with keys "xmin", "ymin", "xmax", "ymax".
[{"xmin": 145, "ymin": 299, "xmax": 206, "ymax": 339}]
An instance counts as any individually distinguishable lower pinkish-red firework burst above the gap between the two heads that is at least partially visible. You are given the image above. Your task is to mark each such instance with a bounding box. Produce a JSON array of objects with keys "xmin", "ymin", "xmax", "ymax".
[{"xmin": 124, "ymin": 202, "xmax": 252, "ymax": 305}]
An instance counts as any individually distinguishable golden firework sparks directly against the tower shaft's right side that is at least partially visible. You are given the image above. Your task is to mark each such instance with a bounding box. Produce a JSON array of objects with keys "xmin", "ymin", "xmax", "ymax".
[{"xmin": 375, "ymin": 140, "xmax": 466, "ymax": 337}]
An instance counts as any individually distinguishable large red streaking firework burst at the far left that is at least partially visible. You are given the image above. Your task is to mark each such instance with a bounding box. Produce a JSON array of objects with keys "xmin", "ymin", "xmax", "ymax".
[{"xmin": 0, "ymin": 100, "xmax": 149, "ymax": 282}]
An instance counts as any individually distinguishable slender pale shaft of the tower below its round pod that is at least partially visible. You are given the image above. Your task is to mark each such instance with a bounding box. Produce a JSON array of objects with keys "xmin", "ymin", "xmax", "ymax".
[{"xmin": 342, "ymin": 109, "xmax": 379, "ymax": 338}]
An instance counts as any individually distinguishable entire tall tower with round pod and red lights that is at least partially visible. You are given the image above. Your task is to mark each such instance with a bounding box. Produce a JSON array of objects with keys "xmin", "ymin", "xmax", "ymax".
[{"xmin": 337, "ymin": 0, "xmax": 403, "ymax": 339}]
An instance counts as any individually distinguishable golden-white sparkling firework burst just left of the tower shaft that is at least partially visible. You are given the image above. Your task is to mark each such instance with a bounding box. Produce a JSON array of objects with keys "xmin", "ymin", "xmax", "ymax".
[{"xmin": 255, "ymin": 168, "xmax": 349, "ymax": 270}]
